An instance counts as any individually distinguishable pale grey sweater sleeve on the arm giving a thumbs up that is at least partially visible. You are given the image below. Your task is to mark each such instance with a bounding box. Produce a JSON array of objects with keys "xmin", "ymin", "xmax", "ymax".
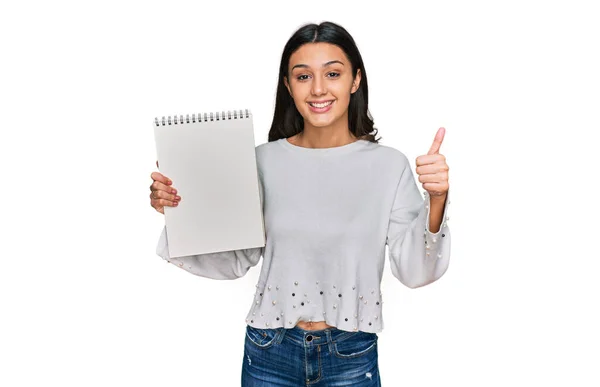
[{"xmin": 386, "ymin": 160, "xmax": 450, "ymax": 288}]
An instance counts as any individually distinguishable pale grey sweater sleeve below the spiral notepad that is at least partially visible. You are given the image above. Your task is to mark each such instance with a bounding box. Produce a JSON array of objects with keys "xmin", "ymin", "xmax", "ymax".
[{"xmin": 156, "ymin": 174, "xmax": 265, "ymax": 280}]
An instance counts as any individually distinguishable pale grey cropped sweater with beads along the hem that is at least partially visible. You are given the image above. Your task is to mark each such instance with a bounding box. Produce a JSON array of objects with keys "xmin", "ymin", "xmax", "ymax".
[{"xmin": 156, "ymin": 138, "xmax": 450, "ymax": 333}]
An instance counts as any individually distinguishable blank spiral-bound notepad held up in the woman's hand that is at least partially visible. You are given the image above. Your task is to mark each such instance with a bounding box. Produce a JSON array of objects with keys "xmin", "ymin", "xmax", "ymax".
[{"xmin": 154, "ymin": 110, "xmax": 265, "ymax": 257}]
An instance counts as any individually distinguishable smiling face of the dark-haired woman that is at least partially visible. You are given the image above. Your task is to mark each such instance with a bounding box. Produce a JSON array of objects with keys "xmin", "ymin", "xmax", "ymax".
[{"xmin": 284, "ymin": 43, "xmax": 360, "ymax": 130}]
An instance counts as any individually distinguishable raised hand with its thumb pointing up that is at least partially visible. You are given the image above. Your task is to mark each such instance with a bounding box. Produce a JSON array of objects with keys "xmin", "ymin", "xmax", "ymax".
[{"xmin": 416, "ymin": 127, "xmax": 450, "ymax": 200}]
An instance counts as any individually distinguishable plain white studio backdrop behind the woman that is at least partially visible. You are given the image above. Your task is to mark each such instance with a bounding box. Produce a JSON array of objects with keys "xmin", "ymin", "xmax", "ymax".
[{"xmin": 0, "ymin": 1, "xmax": 600, "ymax": 387}]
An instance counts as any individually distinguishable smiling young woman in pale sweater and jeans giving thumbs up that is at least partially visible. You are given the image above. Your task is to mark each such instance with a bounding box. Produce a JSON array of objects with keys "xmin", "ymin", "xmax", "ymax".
[{"xmin": 150, "ymin": 22, "xmax": 450, "ymax": 386}]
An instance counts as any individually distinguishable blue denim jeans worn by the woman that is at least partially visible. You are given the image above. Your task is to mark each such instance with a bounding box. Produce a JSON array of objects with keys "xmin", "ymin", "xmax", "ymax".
[{"xmin": 242, "ymin": 325, "xmax": 381, "ymax": 387}]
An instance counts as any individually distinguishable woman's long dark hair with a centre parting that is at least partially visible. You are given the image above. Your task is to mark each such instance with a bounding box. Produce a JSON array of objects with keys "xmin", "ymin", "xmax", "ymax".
[{"xmin": 269, "ymin": 22, "xmax": 381, "ymax": 143}]
